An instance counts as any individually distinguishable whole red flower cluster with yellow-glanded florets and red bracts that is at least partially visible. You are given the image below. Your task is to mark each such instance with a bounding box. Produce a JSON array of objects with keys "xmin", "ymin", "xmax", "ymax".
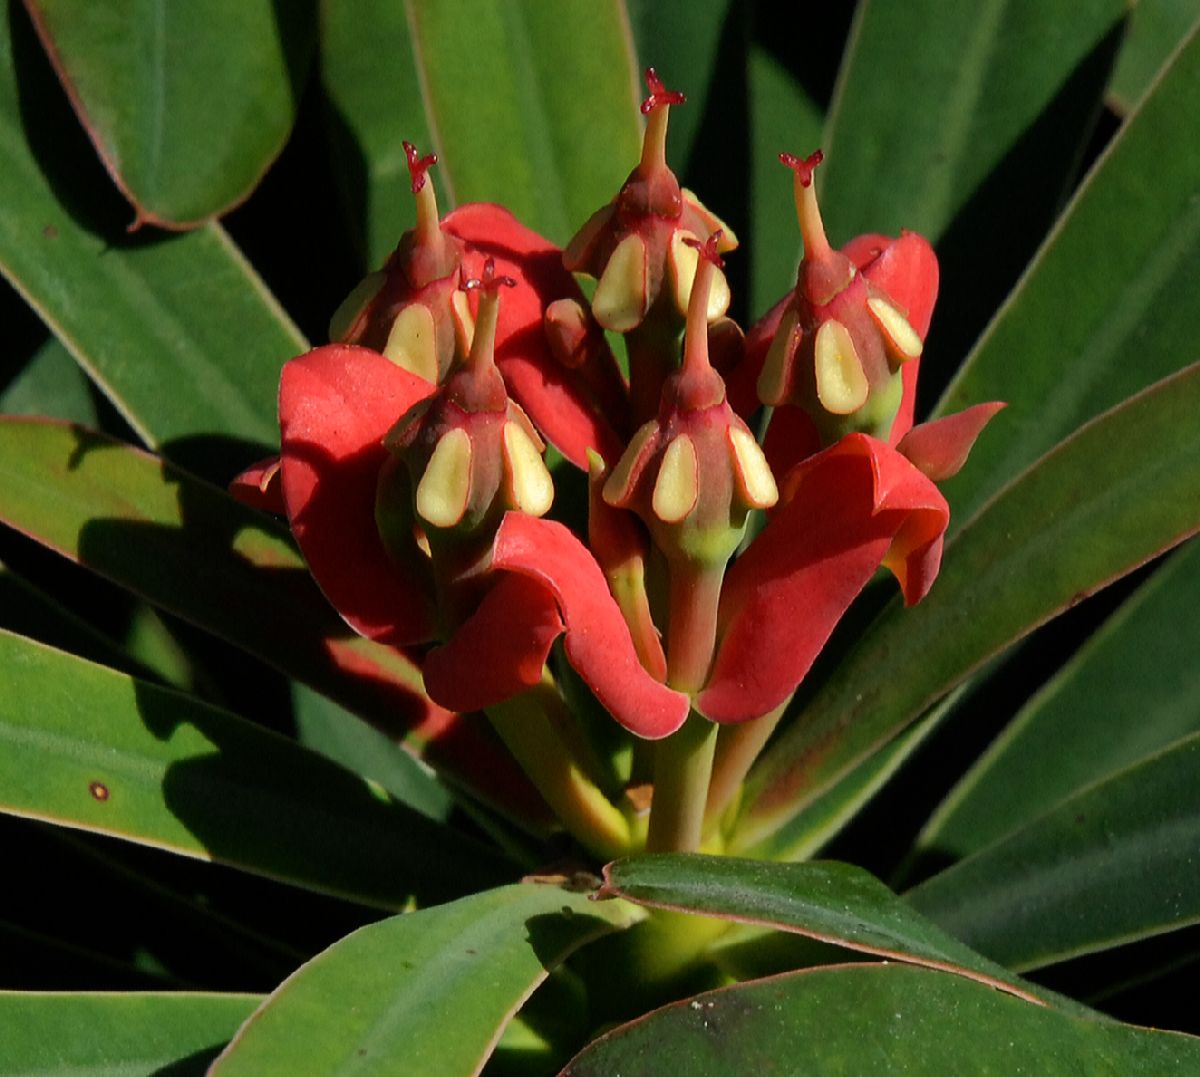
[{"xmin": 233, "ymin": 68, "xmax": 1000, "ymax": 852}]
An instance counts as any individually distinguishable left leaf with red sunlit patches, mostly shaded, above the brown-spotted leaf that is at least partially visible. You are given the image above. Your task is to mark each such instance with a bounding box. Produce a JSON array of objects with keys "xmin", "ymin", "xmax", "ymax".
[{"xmin": 0, "ymin": 419, "xmax": 538, "ymax": 818}]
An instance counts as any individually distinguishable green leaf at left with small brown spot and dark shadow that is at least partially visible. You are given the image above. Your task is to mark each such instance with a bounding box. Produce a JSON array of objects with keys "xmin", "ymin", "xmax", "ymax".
[{"xmin": 0, "ymin": 633, "xmax": 509, "ymax": 908}]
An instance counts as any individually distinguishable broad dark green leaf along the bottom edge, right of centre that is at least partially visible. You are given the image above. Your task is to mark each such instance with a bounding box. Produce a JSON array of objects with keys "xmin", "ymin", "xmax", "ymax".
[{"xmin": 563, "ymin": 965, "xmax": 1200, "ymax": 1077}]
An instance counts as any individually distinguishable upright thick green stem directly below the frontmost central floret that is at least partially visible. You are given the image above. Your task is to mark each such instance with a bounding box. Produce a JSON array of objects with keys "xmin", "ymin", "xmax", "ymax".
[{"xmin": 646, "ymin": 711, "xmax": 718, "ymax": 853}]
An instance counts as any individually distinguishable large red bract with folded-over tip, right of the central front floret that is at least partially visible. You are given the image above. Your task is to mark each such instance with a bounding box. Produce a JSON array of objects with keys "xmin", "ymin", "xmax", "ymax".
[{"xmin": 697, "ymin": 434, "xmax": 949, "ymax": 722}]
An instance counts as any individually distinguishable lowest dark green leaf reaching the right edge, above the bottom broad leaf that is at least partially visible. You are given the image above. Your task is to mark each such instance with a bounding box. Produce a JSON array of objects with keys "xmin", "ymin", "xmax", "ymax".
[{"xmin": 908, "ymin": 734, "xmax": 1200, "ymax": 968}]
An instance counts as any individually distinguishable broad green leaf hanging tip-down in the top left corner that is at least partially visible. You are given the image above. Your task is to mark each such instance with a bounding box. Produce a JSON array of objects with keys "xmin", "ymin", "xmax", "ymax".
[{"xmin": 28, "ymin": 0, "xmax": 316, "ymax": 228}]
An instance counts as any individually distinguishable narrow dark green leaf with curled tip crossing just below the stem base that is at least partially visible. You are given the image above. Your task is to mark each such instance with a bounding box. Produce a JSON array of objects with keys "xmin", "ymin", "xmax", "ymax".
[{"xmin": 601, "ymin": 853, "xmax": 1038, "ymax": 999}]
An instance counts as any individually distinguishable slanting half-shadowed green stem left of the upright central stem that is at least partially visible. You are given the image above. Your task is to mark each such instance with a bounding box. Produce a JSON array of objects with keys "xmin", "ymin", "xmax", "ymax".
[{"xmin": 487, "ymin": 690, "xmax": 631, "ymax": 860}]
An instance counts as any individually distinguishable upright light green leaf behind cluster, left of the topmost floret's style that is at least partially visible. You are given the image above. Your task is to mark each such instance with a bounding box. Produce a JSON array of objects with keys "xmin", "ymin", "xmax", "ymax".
[{"xmin": 405, "ymin": 0, "xmax": 641, "ymax": 243}]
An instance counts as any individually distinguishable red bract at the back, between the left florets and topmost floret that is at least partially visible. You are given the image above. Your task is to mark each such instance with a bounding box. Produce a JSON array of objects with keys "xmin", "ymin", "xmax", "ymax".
[{"xmin": 442, "ymin": 203, "xmax": 622, "ymax": 471}]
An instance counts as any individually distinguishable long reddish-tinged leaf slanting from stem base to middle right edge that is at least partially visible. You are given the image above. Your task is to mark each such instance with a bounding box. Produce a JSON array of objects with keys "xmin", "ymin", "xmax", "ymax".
[{"xmin": 737, "ymin": 365, "xmax": 1200, "ymax": 854}]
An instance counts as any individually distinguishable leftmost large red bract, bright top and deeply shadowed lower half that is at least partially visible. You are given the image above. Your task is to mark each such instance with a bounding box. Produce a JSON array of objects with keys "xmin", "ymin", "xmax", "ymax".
[{"xmin": 280, "ymin": 344, "xmax": 434, "ymax": 645}]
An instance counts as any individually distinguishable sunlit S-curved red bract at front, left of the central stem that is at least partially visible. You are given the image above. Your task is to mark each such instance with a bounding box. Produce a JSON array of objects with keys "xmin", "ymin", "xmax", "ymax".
[{"xmin": 492, "ymin": 512, "xmax": 690, "ymax": 740}]
